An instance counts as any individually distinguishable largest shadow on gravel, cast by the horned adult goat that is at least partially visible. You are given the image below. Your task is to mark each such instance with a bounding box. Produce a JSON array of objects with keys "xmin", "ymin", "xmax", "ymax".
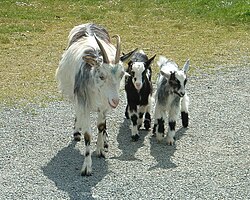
[{"xmin": 42, "ymin": 141, "xmax": 107, "ymax": 200}]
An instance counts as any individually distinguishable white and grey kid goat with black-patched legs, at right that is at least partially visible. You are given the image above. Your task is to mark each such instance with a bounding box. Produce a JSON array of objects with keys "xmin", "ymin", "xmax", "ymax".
[{"xmin": 153, "ymin": 56, "xmax": 189, "ymax": 145}]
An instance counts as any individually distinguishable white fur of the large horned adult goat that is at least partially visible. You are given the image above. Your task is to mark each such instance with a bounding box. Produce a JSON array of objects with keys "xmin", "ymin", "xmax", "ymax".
[{"xmin": 56, "ymin": 24, "xmax": 125, "ymax": 175}]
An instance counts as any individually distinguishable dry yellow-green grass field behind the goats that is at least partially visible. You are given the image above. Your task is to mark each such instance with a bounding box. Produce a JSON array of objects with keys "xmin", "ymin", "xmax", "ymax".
[{"xmin": 0, "ymin": 0, "xmax": 250, "ymax": 105}]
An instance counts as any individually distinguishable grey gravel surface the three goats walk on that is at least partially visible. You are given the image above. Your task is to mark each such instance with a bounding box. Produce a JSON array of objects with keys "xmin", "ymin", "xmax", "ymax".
[{"xmin": 0, "ymin": 66, "xmax": 250, "ymax": 200}]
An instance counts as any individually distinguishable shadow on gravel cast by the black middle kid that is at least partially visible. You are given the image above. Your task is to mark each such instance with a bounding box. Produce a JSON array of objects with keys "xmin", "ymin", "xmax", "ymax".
[{"xmin": 113, "ymin": 118, "xmax": 148, "ymax": 161}]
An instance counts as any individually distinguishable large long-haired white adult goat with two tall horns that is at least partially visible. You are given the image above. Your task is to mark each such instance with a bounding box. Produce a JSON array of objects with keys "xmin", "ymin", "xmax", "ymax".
[{"xmin": 56, "ymin": 23, "xmax": 135, "ymax": 176}]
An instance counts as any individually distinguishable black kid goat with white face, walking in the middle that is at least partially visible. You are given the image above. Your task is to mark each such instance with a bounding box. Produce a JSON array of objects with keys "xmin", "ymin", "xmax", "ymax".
[{"xmin": 125, "ymin": 50, "xmax": 155, "ymax": 141}]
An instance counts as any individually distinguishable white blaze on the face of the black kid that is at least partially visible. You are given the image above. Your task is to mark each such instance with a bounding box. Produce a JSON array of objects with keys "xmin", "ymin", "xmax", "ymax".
[{"xmin": 132, "ymin": 62, "xmax": 145, "ymax": 90}]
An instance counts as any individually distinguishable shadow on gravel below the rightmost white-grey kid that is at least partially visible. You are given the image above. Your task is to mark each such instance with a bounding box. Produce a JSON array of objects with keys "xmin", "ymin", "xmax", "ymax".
[{"xmin": 149, "ymin": 128, "xmax": 187, "ymax": 171}]
